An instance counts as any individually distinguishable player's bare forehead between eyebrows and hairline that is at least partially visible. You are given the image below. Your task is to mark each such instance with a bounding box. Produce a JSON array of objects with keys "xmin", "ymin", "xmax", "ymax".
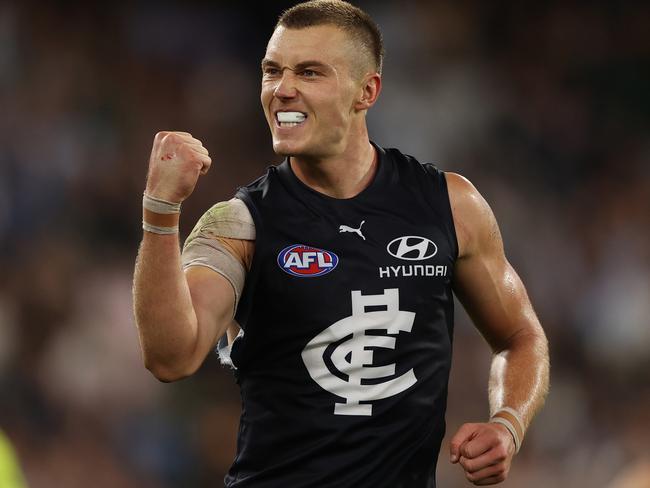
[{"xmin": 266, "ymin": 25, "xmax": 354, "ymax": 66}]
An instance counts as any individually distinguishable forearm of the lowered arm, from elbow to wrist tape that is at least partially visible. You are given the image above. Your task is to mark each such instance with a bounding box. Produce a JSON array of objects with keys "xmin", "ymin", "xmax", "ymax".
[{"xmin": 489, "ymin": 327, "xmax": 549, "ymax": 430}]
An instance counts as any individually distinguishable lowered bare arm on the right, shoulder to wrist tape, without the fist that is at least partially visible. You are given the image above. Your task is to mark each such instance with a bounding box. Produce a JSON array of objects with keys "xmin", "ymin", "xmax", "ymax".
[{"xmin": 448, "ymin": 174, "xmax": 548, "ymax": 427}]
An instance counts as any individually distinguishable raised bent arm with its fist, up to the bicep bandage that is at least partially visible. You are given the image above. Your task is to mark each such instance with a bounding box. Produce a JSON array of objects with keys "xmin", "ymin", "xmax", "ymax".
[{"xmin": 133, "ymin": 132, "xmax": 235, "ymax": 381}]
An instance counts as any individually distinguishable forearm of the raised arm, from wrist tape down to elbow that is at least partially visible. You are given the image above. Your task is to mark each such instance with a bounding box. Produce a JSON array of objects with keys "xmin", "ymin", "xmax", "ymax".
[{"xmin": 133, "ymin": 227, "xmax": 197, "ymax": 380}]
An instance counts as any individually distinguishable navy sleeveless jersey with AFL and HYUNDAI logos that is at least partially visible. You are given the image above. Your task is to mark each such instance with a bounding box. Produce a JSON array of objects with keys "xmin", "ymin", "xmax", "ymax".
[{"xmin": 225, "ymin": 146, "xmax": 458, "ymax": 488}]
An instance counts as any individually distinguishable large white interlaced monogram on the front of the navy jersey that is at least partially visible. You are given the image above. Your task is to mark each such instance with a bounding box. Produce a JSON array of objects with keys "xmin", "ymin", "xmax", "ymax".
[{"xmin": 302, "ymin": 288, "xmax": 417, "ymax": 415}]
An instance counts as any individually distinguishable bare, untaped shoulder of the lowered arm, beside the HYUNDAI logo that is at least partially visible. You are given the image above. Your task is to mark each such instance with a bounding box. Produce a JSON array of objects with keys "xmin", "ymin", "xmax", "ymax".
[{"xmin": 445, "ymin": 173, "xmax": 501, "ymax": 258}]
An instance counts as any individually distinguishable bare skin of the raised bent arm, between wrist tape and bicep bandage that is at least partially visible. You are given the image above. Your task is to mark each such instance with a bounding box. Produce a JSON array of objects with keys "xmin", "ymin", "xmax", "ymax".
[{"xmin": 133, "ymin": 232, "xmax": 235, "ymax": 381}]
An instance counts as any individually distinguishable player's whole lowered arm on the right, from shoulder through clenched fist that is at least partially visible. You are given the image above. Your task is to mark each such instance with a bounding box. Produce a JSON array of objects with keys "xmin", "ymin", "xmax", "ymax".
[{"xmin": 446, "ymin": 173, "xmax": 549, "ymax": 485}]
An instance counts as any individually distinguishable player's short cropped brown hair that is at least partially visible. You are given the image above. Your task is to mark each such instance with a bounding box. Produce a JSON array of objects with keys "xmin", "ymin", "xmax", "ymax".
[{"xmin": 275, "ymin": 0, "xmax": 384, "ymax": 74}]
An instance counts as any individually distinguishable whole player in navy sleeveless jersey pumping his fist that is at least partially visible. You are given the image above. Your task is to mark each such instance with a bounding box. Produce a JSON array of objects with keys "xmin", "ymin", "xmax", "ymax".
[{"xmin": 134, "ymin": 0, "xmax": 549, "ymax": 488}]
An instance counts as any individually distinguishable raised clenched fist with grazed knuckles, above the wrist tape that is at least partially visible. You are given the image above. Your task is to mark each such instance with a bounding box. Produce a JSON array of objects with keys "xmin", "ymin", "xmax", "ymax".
[{"xmin": 145, "ymin": 131, "xmax": 212, "ymax": 203}]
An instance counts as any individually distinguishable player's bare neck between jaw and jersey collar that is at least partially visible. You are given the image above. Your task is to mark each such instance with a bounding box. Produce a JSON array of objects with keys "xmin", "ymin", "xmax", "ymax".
[{"xmin": 289, "ymin": 134, "xmax": 377, "ymax": 199}]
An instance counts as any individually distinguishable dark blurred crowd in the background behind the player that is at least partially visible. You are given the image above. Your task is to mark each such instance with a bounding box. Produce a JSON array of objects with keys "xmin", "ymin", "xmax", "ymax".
[{"xmin": 0, "ymin": 0, "xmax": 650, "ymax": 488}]
